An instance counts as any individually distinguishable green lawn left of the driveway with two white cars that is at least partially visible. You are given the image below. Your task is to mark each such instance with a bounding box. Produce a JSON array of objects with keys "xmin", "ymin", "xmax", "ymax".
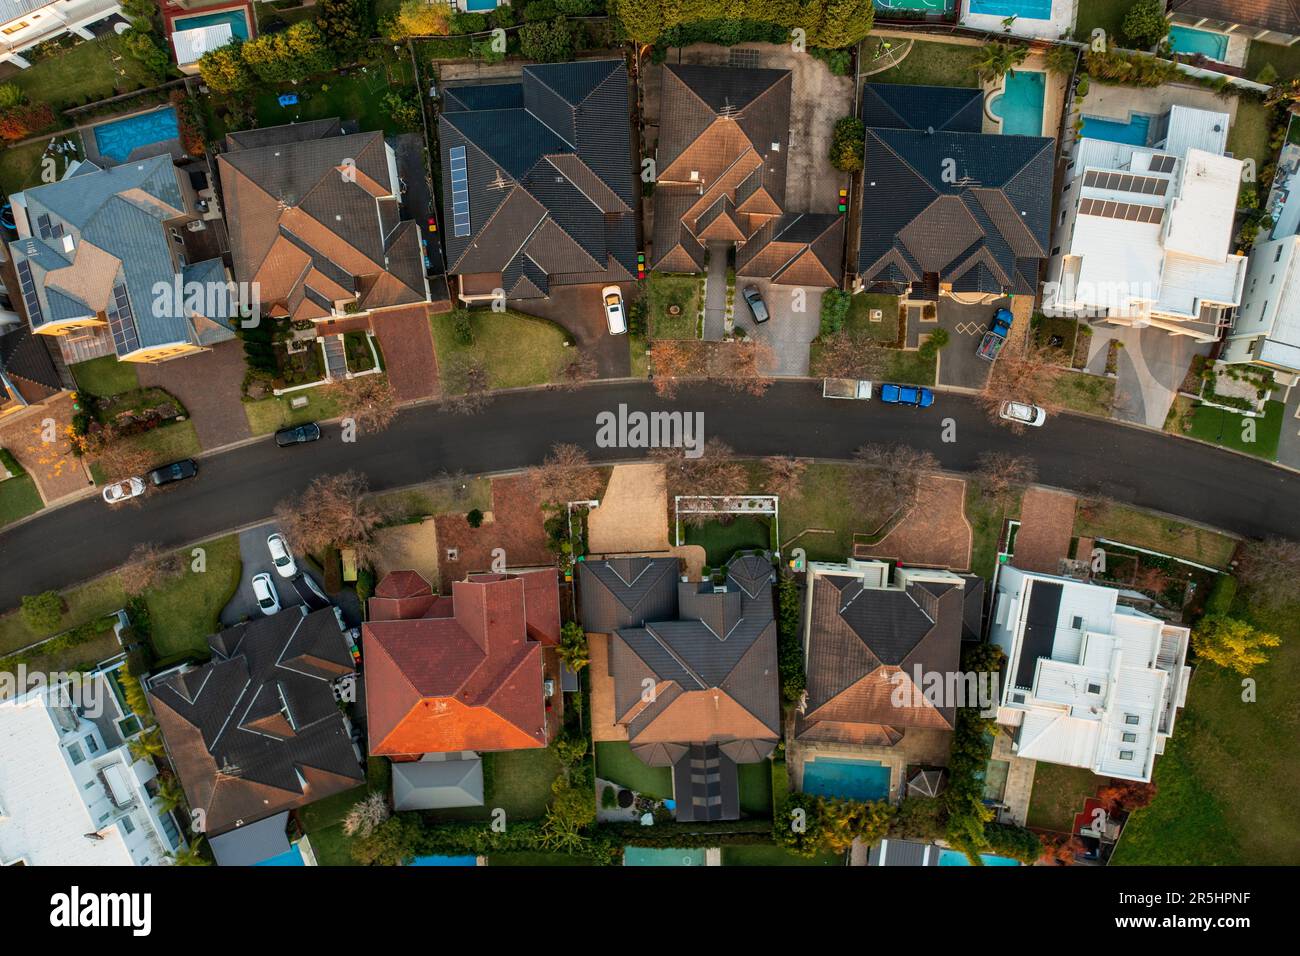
[{"xmin": 146, "ymin": 535, "xmax": 243, "ymax": 659}]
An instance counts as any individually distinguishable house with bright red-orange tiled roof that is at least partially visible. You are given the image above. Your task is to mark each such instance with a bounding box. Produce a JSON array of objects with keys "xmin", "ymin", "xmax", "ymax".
[{"xmin": 361, "ymin": 570, "xmax": 560, "ymax": 761}]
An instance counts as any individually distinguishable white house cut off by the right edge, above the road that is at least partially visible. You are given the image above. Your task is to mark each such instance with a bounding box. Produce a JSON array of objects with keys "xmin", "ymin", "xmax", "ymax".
[{"xmin": 1219, "ymin": 235, "xmax": 1300, "ymax": 375}]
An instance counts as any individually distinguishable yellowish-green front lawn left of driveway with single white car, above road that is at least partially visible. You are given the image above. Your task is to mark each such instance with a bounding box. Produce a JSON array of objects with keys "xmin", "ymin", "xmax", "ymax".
[{"xmin": 429, "ymin": 310, "xmax": 571, "ymax": 394}]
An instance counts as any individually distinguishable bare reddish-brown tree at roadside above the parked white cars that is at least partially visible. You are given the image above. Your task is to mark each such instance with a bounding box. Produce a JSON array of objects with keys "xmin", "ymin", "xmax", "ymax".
[{"xmin": 276, "ymin": 471, "xmax": 382, "ymax": 561}]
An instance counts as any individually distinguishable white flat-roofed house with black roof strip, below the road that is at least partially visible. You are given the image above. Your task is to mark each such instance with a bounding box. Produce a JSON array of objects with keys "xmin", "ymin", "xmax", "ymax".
[{"xmin": 989, "ymin": 564, "xmax": 1191, "ymax": 782}]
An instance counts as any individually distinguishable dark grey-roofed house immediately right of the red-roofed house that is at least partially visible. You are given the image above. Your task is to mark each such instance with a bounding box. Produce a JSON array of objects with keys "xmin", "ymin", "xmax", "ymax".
[{"xmin": 579, "ymin": 554, "xmax": 781, "ymax": 822}]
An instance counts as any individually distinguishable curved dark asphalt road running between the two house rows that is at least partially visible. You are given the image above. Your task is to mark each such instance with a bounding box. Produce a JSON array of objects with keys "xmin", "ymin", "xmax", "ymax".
[{"xmin": 0, "ymin": 381, "xmax": 1300, "ymax": 609}]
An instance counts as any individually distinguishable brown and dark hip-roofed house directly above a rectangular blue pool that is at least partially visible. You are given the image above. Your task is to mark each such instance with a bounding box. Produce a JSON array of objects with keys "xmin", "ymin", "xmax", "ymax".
[{"xmin": 794, "ymin": 558, "xmax": 984, "ymax": 749}]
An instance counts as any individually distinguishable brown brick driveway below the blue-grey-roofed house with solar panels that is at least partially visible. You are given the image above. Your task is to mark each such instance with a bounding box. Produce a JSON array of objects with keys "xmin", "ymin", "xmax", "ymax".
[{"xmin": 139, "ymin": 339, "xmax": 251, "ymax": 451}]
